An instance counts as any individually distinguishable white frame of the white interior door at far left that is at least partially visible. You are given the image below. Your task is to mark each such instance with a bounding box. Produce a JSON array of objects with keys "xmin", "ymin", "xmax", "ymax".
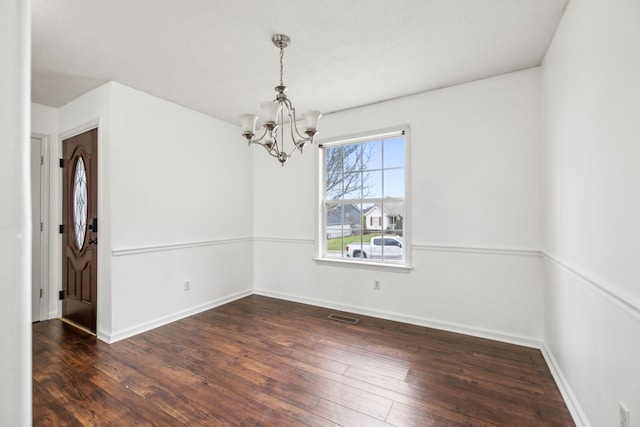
[{"xmin": 29, "ymin": 132, "xmax": 51, "ymax": 321}]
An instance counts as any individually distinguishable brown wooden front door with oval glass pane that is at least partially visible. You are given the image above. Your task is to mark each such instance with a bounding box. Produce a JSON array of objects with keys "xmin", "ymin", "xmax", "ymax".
[{"xmin": 62, "ymin": 129, "xmax": 98, "ymax": 332}]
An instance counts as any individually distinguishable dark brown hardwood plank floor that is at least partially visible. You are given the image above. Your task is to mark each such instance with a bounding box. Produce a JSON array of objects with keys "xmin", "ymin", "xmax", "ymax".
[{"xmin": 33, "ymin": 295, "xmax": 574, "ymax": 426}]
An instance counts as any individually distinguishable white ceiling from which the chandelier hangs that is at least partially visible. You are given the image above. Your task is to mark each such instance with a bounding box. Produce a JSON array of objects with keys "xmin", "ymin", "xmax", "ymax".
[{"xmin": 32, "ymin": 0, "xmax": 567, "ymax": 123}]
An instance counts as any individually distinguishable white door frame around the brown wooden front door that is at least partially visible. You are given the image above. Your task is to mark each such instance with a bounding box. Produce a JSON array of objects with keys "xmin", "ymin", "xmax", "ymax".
[{"xmin": 58, "ymin": 119, "xmax": 101, "ymax": 334}]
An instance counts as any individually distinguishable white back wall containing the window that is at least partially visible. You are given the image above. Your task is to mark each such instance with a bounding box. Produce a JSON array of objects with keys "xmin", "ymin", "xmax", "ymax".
[{"xmin": 252, "ymin": 69, "xmax": 542, "ymax": 344}]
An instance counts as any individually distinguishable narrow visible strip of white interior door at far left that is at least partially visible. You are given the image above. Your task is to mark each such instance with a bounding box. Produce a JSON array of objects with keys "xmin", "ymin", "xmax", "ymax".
[{"xmin": 31, "ymin": 138, "xmax": 43, "ymax": 322}]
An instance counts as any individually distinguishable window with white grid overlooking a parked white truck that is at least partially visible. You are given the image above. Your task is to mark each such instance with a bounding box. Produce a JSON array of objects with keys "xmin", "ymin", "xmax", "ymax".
[{"xmin": 319, "ymin": 127, "xmax": 410, "ymax": 266}]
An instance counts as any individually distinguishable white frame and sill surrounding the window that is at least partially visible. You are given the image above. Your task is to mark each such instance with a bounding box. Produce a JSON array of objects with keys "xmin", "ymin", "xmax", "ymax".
[{"xmin": 315, "ymin": 125, "xmax": 412, "ymax": 272}]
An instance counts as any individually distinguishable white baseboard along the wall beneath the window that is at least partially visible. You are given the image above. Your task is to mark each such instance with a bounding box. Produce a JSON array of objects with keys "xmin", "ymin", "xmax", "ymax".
[{"xmin": 253, "ymin": 289, "xmax": 541, "ymax": 349}]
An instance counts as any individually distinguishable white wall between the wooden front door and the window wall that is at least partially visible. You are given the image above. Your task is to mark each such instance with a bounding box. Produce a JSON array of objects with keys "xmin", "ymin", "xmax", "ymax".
[{"xmin": 54, "ymin": 82, "xmax": 253, "ymax": 342}]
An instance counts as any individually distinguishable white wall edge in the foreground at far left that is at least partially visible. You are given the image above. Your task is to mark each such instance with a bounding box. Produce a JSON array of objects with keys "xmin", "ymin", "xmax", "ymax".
[{"xmin": 0, "ymin": 0, "xmax": 31, "ymax": 426}]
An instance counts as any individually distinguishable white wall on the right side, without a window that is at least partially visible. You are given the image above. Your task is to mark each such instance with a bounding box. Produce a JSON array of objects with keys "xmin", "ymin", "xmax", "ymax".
[{"xmin": 542, "ymin": 0, "xmax": 640, "ymax": 426}]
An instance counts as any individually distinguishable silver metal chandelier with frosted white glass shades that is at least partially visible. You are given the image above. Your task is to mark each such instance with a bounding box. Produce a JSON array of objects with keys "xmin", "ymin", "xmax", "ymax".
[{"xmin": 240, "ymin": 34, "xmax": 322, "ymax": 166}]
